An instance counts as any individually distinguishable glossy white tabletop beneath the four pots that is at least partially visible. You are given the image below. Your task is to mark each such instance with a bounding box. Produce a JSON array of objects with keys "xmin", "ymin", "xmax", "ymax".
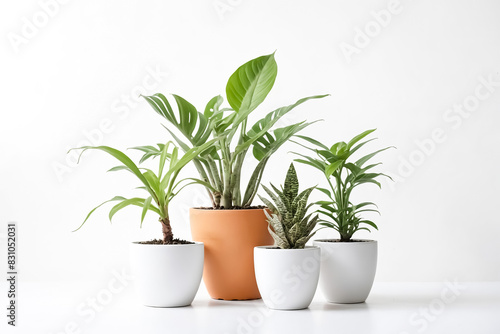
[{"xmin": 0, "ymin": 282, "xmax": 500, "ymax": 334}]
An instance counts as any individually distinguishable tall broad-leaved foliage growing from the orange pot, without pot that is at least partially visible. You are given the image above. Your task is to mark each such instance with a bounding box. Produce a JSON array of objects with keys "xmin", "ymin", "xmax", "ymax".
[{"xmin": 144, "ymin": 54, "xmax": 327, "ymax": 209}]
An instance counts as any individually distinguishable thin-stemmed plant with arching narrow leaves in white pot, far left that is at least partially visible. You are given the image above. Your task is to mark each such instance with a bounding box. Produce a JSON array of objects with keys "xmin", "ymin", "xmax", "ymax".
[{"xmin": 72, "ymin": 141, "xmax": 213, "ymax": 307}]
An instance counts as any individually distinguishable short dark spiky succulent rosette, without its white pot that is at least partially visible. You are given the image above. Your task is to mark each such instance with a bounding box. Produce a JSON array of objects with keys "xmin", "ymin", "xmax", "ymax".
[{"xmin": 259, "ymin": 163, "xmax": 319, "ymax": 249}]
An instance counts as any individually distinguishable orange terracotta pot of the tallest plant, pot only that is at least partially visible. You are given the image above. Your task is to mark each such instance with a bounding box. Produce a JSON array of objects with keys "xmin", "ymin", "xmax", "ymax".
[{"xmin": 189, "ymin": 208, "xmax": 273, "ymax": 300}]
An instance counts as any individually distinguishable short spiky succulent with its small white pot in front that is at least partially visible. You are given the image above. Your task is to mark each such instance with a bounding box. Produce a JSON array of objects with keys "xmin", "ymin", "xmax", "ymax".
[{"xmin": 254, "ymin": 164, "xmax": 321, "ymax": 310}]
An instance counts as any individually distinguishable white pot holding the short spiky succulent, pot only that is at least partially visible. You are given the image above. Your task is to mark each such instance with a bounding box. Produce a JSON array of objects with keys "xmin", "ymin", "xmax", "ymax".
[{"xmin": 254, "ymin": 246, "xmax": 321, "ymax": 310}]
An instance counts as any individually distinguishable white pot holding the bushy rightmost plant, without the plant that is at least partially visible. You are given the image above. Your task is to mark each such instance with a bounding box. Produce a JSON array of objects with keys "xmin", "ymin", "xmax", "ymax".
[{"xmin": 313, "ymin": 239, "xmax": 377, "ymax": 304}]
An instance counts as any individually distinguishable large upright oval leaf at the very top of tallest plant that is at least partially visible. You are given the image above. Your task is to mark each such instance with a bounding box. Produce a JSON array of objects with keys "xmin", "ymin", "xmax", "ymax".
[{"xmin": 226, "ymin": 53, "xmax": 278, "ymax": 113}]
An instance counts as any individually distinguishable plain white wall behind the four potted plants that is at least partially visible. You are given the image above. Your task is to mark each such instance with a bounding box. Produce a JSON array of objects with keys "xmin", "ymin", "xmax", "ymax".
[{"xmin": 0, "ymin": 0, "xmax": 500, "ymax": 290}]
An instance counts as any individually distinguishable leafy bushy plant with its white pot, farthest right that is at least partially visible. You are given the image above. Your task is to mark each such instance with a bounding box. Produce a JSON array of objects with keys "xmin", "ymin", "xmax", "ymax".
[{"xmin": 295, "ymin": 130, "xmax": 390, "ymax": 303}]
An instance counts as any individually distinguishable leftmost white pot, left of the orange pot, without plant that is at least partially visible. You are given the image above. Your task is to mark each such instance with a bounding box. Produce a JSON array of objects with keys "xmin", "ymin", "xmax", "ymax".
[{"xmin": 130, "ymin": 242, "xmax": 204, "ymax": 307}]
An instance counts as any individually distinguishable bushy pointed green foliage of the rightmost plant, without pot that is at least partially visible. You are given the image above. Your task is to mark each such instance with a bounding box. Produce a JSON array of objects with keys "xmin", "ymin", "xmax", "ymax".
[{"xmin": 295, "ymin": 129, "xmax": 391, "ymax": 241}]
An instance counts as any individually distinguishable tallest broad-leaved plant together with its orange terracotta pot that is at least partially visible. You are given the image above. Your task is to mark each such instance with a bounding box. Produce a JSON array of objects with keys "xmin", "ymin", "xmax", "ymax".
[{"xmin": 144, "ymin": 54, "xmax": 327, "ymax": 300}]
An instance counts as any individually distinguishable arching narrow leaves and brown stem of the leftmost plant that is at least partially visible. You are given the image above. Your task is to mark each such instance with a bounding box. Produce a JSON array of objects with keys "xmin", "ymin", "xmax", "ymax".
[{"xmin": 73, "ymin": 140, "xmax": 214, "ymax": 244}]
